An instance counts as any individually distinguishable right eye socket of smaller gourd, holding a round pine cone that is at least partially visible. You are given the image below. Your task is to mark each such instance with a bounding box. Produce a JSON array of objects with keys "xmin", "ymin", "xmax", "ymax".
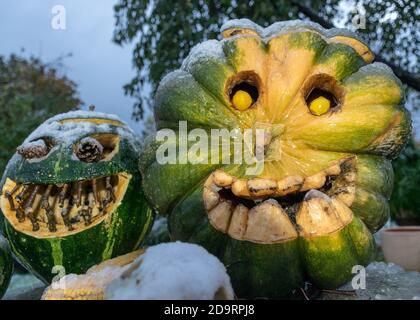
[{"xmin": 73, "ymin": 134, "xmax": 120, "ymax": 163}]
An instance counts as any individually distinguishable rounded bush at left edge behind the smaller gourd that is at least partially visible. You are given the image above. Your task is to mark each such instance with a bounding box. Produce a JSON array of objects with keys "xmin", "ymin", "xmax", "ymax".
[{"xmin": 0, "ymin": 55, "xmax": 81, "ymax": 172}]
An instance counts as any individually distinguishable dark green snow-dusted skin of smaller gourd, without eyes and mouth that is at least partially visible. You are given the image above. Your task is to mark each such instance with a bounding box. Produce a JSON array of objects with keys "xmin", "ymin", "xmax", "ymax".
[{"xmin": 0, "ymin": 111, "xmax": 153, "ymax": 283}]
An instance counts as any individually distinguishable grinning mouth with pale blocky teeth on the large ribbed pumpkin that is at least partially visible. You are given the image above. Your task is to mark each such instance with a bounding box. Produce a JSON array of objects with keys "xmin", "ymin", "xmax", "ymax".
[{"xmin": 203, "ymin": 157, "xmax": 357, "ymax": 243}]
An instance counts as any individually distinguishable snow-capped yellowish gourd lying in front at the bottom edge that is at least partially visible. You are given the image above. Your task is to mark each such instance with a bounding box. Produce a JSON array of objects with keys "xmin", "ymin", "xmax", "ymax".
[{"xmin": 42, "ymin": 242, "xmax": 234, "ymax": 300}]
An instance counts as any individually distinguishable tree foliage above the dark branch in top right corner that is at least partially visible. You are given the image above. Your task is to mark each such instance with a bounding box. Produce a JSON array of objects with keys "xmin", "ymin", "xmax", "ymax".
[{"xmin": 313, "ymin": 0, "xmax": 420, "ymax": 75}]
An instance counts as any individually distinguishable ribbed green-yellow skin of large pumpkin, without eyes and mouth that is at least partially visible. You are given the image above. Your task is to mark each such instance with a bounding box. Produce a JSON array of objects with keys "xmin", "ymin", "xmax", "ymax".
[{"xmin": 140, "ymin": 20, "xmax": 411, "ymax": 298}]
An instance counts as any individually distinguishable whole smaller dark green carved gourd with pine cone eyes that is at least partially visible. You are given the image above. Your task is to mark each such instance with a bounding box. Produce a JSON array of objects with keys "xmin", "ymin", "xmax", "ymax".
[{"xmin": 0, "ymin": 111, "xmax": 153, "ymax": 282}]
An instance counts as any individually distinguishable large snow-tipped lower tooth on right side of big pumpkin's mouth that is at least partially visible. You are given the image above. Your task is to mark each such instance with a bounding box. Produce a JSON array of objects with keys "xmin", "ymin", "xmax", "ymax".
[{"xmin": 296, "ymin": 190, "xmax": 353, "ymax": 236}]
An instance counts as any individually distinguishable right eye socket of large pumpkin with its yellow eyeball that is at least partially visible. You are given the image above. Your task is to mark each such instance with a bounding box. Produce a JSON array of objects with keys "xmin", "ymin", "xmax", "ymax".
[{"xmin": 303, "ymin": 74, "xmax": 344, "ymax": 116}]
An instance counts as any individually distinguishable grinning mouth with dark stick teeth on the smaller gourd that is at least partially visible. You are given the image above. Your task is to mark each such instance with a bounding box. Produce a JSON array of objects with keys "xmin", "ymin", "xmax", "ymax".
[{"xmin": 0, "ymin": 173, "xmax": 131, "ymax": 238}]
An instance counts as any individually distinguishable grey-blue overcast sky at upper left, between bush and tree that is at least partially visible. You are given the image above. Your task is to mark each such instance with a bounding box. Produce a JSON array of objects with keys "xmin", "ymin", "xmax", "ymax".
[{"xmin": 0, "ymin": 0, "xmax": 140, "ymax": 131}]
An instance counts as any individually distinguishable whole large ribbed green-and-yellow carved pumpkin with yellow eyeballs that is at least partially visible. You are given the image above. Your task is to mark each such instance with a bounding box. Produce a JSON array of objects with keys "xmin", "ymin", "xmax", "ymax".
[{"xmin": 140, "ymin": 20, "xmax": 411, "ymax": 297}]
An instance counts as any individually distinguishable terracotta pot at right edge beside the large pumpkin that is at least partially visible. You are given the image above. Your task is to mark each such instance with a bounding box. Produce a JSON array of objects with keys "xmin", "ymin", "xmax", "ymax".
[{"xmin": 381, "ymin": 226, "xmax": 420, "ymax": 271}]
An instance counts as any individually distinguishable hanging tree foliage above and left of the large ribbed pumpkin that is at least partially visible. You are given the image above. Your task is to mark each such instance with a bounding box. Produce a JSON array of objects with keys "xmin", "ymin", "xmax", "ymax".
[{"xmin": 114, "ymin": 0, "xmax": 297, "ymax": 120}]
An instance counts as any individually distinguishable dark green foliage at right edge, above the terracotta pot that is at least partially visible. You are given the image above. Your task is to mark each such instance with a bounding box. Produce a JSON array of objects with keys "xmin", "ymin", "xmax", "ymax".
[{"xmin": 390, "ymin": 140, "xmax": 420, "ymax": 224}]
